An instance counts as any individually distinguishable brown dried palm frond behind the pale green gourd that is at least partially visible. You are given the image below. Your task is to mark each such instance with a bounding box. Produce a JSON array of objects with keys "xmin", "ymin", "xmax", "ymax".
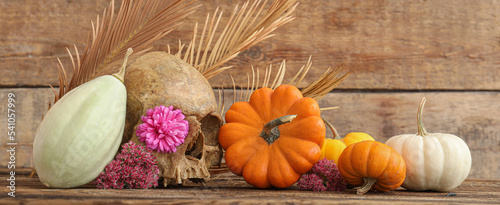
[{"xmin": 49, "ymin": 0, "xmax": 197, "ymax": 109}]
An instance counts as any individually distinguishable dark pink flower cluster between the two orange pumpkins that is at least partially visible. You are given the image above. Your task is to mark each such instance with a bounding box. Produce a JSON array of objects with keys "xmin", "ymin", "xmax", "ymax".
[{"xmin": 297, "ymin": 159, "xmax": 347, "ymax": 191}]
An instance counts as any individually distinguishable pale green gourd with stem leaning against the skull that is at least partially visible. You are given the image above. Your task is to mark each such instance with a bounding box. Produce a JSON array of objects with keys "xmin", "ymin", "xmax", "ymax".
[{"xmin": 33, "ymin": 48, "xmax": 132, "ymax": 188}]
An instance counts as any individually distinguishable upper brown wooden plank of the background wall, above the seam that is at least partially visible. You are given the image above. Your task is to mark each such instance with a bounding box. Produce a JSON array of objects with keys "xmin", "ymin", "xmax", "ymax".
[{"xmin": 0, "ymin": 0, "xmax": 500, "ymax": 90}]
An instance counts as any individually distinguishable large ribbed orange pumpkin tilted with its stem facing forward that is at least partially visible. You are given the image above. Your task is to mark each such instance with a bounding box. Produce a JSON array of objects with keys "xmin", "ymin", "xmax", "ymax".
[{"xmin": 219, "ymin": 85, "xmax": 326, "ymax": 188}]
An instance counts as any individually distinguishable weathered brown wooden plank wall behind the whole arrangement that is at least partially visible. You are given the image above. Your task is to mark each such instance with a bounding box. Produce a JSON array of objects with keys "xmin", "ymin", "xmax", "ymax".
[{"xmin": 0, "ymin": 0, "xmax": 500, "ymax": 179}]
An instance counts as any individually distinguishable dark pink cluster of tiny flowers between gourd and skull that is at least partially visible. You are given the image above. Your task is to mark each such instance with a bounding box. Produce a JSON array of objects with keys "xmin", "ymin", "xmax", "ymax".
[{"xmin": 94, "ymin": 141, "xmax": 160, "ymax": 189}]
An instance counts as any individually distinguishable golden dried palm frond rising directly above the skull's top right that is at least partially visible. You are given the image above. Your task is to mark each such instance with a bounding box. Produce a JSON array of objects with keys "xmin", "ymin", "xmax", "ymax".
[{"xmin": 177, "ymin": 0, "xmax": 298, "ymax": 79}]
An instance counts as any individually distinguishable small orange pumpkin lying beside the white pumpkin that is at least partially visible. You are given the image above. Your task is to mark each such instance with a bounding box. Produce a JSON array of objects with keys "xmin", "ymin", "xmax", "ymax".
[{"xmin": 338, "ymin": 141, "xmax": 406, "ymax": 194}]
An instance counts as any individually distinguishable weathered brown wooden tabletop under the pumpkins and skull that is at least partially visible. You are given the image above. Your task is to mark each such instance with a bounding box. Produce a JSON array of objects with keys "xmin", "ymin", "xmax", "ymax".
[{"xmin": 0, "ymin": 168, "xmax": 500, "ymax": 204}]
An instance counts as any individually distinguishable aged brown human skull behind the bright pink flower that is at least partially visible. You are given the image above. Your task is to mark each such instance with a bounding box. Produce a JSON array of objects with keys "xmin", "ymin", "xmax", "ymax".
[{"xmin": 97, "ymin": 51, "xmax": 222, "ymax": 186}]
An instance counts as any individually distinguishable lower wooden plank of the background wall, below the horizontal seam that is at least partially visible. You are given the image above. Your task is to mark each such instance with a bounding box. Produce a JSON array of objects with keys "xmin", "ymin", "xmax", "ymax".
[{"xmin": 0, "ymin": 88, "xmax": 500, "ymax": 179}]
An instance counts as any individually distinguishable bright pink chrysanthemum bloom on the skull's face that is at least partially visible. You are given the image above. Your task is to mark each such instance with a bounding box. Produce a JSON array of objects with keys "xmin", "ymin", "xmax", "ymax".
[{"xmin": 135, "ymin": 105, "xmax": 189, "ymax": 153}]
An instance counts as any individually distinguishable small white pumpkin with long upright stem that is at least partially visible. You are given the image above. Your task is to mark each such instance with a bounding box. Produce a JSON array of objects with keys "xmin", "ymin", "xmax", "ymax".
[{"xmin": 385, "ymin": 97, "xmax": 472, "ymax": 191}]
